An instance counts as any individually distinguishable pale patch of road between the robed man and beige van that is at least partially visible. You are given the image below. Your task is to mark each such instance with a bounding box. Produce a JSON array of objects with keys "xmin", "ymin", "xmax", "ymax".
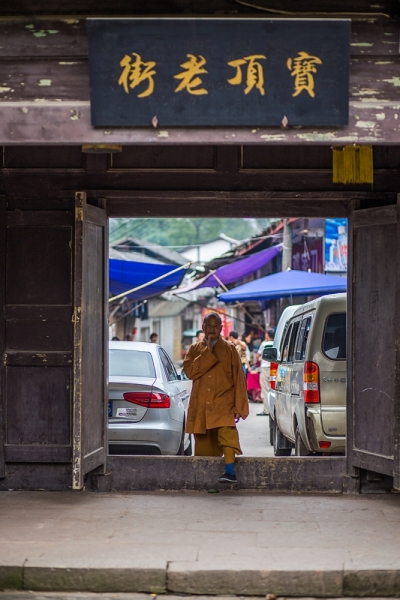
[{"xmin": 238, "ymin": 402, "xmax": 274, "ymax": 457}]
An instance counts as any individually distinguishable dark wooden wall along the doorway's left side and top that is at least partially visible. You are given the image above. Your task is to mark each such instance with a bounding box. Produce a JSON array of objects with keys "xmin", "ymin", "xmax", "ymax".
[{"xmin": 0, "ymin": 146, "xmax": 399, "ymax": 489}]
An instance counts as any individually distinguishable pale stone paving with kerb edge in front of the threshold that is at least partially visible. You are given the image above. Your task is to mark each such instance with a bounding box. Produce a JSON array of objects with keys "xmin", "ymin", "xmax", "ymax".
[{"xmin": 0, "ymin": 492, "xmax": 400, "ymax": 597}]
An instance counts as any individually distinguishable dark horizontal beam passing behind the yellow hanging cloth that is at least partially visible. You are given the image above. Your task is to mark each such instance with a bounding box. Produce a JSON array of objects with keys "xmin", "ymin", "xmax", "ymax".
[{"xmin": 0, "ymin": 169, "xmax": 400, "ymax": 199}]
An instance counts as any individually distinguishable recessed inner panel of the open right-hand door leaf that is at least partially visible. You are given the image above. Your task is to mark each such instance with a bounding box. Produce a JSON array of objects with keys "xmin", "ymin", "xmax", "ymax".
[{"xmin": 354, "ymin": 223, "xmax": 397, "ymax": 457}]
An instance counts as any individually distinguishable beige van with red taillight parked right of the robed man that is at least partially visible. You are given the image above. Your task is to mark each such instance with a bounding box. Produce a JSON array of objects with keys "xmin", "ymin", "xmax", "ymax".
[{"xmin": 265, "ymin": 294, "xmax": 347, "ymax": 456}]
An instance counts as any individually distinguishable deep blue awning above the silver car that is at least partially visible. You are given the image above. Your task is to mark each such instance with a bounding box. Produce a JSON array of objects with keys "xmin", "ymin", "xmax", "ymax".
[{"xmin": 109, "ymin": 258, "xmax": 186, "ymax": 300}]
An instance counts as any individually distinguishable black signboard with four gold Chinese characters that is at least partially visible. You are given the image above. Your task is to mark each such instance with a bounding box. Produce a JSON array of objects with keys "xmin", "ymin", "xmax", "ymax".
[{"xmin": 87, "ymin": 18, "xmax": 350, "ymax": 127}]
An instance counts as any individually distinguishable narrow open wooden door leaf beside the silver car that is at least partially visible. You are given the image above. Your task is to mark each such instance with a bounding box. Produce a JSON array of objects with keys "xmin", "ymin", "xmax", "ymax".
[{"xmin": 72, "ymin": 192, "xmax": 108, "ymax": 489}]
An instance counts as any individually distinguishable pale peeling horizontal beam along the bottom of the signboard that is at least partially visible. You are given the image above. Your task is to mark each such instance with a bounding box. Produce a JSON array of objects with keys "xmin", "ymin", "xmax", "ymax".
[{"xmin": 0, "ymin": 101, "xmax": 400, "ymax": 146}]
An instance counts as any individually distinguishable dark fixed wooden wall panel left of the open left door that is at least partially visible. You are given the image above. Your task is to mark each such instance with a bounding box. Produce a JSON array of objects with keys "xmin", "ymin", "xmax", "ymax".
[{"xmin": 2, "ymin": 210, "xmax": 73, "ymax": 469}]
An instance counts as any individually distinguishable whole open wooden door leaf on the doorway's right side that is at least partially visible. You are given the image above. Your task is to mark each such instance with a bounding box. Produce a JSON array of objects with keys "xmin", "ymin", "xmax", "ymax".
[{"xmin": 347, "ymin": 205, "xmax": 399, "ymax": 480}]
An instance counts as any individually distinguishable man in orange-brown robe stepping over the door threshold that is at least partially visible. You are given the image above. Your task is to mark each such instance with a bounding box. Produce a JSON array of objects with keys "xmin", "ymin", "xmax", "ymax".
[{"xmin": 183, "ymin": 313, "xmax": 249, "ymax": 483}]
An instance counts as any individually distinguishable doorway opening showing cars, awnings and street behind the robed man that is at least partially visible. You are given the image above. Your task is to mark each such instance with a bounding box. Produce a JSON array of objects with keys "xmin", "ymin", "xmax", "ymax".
[{"xmin": 108, "ymin": 217, "xmax": 348, "ymax": 458}]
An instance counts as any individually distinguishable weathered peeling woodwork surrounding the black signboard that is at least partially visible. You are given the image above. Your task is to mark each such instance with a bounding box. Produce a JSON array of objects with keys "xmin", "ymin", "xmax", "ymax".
[{"xmin": 0, "ymin": 9, "xmax": 400, "ymax": 145}]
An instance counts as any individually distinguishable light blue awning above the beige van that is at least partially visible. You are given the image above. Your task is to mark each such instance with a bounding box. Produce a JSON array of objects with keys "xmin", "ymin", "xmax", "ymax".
[{"xmin": 219, "ymin": 271, "xmax": 347, "ymax": 302}]
